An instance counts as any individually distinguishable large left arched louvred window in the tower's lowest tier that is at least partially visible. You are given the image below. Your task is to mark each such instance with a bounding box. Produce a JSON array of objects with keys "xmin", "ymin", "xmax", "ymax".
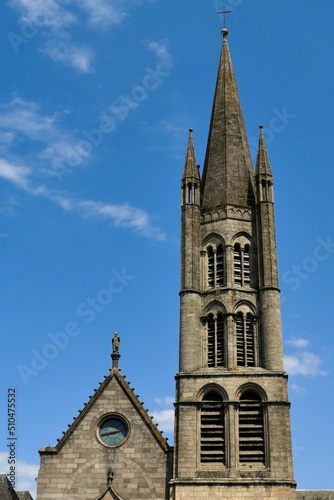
[{"xmin": 201, "ymin": 391, "xmax": 225, "ymax": 464}]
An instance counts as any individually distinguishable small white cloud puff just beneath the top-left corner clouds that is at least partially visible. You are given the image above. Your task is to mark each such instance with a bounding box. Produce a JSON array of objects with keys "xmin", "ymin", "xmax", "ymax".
[{"xmin": 40, "ymin": 40, "xmax": 95, "ymax": 74}]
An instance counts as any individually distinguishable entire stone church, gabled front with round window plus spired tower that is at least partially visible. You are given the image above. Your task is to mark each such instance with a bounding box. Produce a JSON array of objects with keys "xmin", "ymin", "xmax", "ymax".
[{"xmin": 37, "ymin": 29, "xmax": 334, "ymax": 500}]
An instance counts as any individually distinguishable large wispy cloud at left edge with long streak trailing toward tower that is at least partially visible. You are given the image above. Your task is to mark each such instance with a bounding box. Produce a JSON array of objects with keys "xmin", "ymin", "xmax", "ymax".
[{"xmin": 0, "ymin": 97, "xmax": 166, "ymax": 241}]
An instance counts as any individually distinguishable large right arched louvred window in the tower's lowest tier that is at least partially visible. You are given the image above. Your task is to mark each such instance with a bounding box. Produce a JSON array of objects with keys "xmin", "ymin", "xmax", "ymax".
[{"xmin": 239, "ymin": 390, "xmax": 265, "ymax": 465}]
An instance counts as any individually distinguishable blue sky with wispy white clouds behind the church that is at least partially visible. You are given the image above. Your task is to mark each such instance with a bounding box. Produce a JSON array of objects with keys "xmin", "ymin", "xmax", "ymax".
[{"xmin": 0, "ymin": 0, "xmax": 334, "ymax": 491}]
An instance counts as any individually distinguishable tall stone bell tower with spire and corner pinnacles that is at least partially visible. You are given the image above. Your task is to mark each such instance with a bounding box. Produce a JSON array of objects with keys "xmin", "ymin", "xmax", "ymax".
[{"xmin": 170, "ymin": 29, "xmax": 296, "ymax": 500}]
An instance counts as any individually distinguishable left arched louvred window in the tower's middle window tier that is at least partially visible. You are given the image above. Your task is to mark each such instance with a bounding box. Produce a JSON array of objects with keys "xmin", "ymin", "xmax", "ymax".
[{"xmin": 207, "ymin": 313, "xmax": 225, "ymax": 367}]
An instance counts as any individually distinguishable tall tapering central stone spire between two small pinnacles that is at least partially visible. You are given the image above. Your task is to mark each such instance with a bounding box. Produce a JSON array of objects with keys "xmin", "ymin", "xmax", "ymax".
[{"xmin": 202, "ymin": 29, "xmax": 254, "ymax": 209}]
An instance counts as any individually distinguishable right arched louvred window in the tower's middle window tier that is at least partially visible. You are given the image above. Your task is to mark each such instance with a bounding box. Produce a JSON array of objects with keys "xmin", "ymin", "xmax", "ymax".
[{"xmin": 235, "ymin": 313, "xmax": 255, "ymax": 366}]
